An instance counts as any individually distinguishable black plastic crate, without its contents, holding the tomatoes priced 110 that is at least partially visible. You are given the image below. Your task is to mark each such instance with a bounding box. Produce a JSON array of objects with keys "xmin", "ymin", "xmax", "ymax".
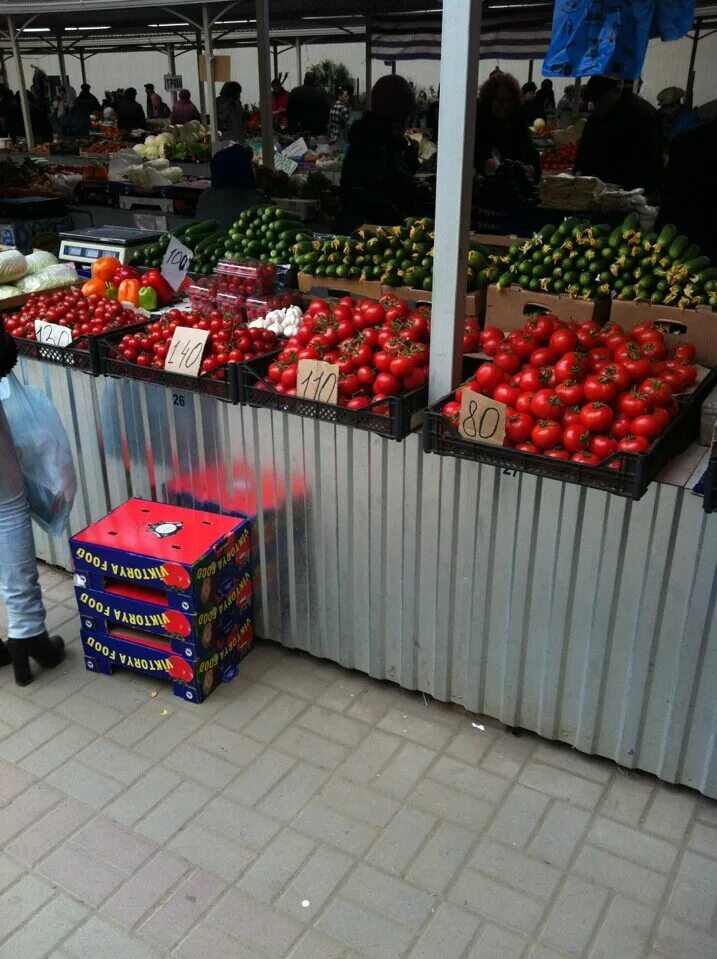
[{"xmin": 238, "ymin": 354, "xmax": 428, "ymax": 440}]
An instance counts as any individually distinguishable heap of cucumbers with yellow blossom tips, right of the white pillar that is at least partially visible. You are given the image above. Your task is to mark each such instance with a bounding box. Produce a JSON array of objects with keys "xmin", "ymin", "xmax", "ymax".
[{"xmin": 478, "ymin": 213, "xmax": 717, "ymax": 309}]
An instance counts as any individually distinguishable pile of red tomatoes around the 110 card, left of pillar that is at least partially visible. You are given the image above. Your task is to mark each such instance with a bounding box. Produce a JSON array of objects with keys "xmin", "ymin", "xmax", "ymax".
[{"xmin": 268, "ymin": 296, "xmax": 431, "ymax": 410}]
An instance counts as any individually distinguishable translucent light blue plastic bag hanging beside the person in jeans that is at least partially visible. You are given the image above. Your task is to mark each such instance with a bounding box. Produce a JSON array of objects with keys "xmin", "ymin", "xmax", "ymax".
[{"xmin": 2, "ymin": 373, "xmax": 77, "ymax": 536}]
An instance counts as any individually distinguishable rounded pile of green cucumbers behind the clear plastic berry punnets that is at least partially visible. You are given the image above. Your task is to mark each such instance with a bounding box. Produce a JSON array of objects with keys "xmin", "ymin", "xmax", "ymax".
[{"xmin": 225, "ymin": 206, "xmax": 314, "ymax": 266}]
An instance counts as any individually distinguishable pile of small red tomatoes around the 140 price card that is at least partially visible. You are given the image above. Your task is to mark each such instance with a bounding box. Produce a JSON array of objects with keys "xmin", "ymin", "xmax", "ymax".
[{"xmin": 117, "ymin": 310, "xmax": 278, "ymax": 380}]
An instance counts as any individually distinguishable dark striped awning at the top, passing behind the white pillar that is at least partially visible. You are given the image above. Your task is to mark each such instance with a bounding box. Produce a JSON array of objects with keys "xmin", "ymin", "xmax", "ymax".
[{"xmin": 370, "ymin": 4, "xmax": 552, "ymax": 60}]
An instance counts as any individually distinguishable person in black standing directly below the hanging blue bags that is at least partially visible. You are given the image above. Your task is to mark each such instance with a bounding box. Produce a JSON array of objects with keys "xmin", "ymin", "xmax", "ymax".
[{"xmin": 575, "ymin": 76, "xmax": 662, "ymax": 194}]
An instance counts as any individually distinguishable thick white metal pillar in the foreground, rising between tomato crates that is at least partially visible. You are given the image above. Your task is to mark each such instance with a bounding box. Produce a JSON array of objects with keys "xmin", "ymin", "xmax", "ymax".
[{"xmin": 428, "ymin": 0, "xmax": 483, "ymax": 403}]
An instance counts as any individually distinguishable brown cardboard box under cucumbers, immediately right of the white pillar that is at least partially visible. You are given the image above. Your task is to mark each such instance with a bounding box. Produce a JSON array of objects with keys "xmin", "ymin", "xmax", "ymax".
[{"xmin": 485, "ymin": 284, "xmax": 608, "ymax": 330}]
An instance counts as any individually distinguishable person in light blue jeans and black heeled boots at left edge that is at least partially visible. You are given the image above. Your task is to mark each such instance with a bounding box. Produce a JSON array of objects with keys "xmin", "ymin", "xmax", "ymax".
[{"xmin": 0, "ymin": 326, "xmax": 65, "ymax": 686}]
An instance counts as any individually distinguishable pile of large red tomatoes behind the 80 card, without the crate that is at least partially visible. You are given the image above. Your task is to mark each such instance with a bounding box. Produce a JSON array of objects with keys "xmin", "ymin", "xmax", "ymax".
[{"xmin": 442, "ymin": 315, "xmax": 697, "ymax": 468}]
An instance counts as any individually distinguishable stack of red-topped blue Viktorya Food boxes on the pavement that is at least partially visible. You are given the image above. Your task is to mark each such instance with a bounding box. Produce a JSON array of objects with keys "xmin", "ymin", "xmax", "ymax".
[{"xmin": 70, "ymin": 499, "xmax": 253, "ymax": 702}]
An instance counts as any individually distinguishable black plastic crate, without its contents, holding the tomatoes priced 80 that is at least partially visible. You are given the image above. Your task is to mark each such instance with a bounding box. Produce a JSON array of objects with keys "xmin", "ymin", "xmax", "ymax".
[{"xmin": 423, "ymin": 370, "xmax": 717, "ymax": 500}]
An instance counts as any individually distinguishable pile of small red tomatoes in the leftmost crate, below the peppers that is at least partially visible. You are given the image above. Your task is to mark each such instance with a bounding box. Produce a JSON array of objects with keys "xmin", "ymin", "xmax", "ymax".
[{"xmin": 3, "ymin": 287, "xmax": 141, "ymax": 346}]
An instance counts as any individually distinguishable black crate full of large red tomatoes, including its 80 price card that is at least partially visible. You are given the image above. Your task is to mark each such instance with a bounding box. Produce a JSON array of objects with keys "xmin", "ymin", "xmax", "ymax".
[{"xmin": 424, "ymin": 314, "xmax": 717, "ymax": 499}]
